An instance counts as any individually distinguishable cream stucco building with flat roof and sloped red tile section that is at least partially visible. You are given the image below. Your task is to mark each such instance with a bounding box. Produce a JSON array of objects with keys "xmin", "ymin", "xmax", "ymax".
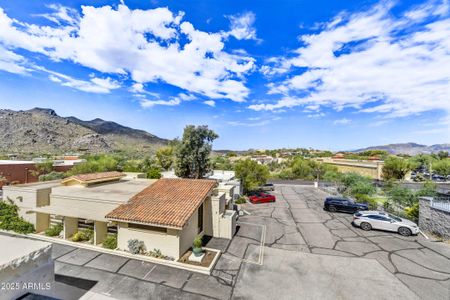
[{"xmin": 4, "ymin": 172, "xmax": 236, "ymax": 259}]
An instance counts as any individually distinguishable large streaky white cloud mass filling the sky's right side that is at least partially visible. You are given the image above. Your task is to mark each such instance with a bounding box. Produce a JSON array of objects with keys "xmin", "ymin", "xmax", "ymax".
[{"xmin": 253, "ymin": 1, "xmax": 450, "ymax": 117}]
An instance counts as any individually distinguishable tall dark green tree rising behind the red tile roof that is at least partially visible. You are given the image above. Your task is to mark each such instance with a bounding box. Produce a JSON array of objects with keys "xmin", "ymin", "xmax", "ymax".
[{"xmin": 175, "ymin": 125, "xmax": 219, "ymax": 178}]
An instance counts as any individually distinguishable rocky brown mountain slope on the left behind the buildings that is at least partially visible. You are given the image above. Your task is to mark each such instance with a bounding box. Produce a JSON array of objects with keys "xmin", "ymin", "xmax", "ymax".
[{"xmin": 0, "ymin": 108, "xmax": 168, "ymax": 154}]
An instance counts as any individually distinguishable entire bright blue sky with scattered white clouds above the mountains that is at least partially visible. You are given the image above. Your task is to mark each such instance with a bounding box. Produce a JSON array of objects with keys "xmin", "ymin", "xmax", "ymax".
[{"xmin": 0, "ymin": 0, "xmax": 450, "ymax": 150}]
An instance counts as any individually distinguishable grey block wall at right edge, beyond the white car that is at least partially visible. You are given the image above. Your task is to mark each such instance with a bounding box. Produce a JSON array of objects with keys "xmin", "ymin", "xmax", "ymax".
[{"xmin": 419, "ymin": 197, "xmax": 450, "ymax": 239}]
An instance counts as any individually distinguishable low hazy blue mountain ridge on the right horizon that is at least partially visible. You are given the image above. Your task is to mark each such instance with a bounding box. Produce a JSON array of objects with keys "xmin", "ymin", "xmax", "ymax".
[{"xmin": 352, "ymin": 143, "xmax": 450, "ymax": 155}]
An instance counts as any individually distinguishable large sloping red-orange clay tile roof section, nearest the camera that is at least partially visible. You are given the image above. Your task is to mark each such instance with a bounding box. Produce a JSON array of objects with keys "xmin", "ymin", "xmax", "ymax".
[{"xmin": 106, "ymin": 178, "xmax": 217, "ymax": 229}]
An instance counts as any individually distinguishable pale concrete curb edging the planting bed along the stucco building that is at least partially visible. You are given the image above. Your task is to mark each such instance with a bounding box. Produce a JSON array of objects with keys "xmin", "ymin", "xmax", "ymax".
[{"xmin": 0, "ymin": 230, "xmax": 222, "ymax": 275}]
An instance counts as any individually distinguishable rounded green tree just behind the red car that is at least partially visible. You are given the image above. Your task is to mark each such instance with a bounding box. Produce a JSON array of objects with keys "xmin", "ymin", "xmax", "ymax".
[{"xmin": 234, "ymin": 159, "xmax": 270, "ymax": 193}]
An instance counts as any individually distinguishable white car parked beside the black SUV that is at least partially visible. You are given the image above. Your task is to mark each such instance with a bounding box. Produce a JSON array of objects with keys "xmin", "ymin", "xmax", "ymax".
[{"xmin": 353, "ymin": 210, "xmax": 419, "ymax": 236}]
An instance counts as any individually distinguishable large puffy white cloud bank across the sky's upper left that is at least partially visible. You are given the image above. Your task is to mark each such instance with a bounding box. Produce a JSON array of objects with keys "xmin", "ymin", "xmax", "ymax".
[{"xmin": 0, "ymin": 4, "xmax": 254, "ymax": 102}]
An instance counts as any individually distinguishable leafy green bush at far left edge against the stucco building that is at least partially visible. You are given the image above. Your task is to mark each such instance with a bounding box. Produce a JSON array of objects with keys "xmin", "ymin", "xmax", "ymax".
[{"xmin": 0, "ymin": 201, "xmax": 34, "ymax": 234}]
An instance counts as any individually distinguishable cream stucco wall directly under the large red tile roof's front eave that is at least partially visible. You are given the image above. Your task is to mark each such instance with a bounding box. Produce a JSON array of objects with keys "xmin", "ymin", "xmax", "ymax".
[{"xmin": 117, "ymin": 222, "xmax": 180, "ymax": 259}]
